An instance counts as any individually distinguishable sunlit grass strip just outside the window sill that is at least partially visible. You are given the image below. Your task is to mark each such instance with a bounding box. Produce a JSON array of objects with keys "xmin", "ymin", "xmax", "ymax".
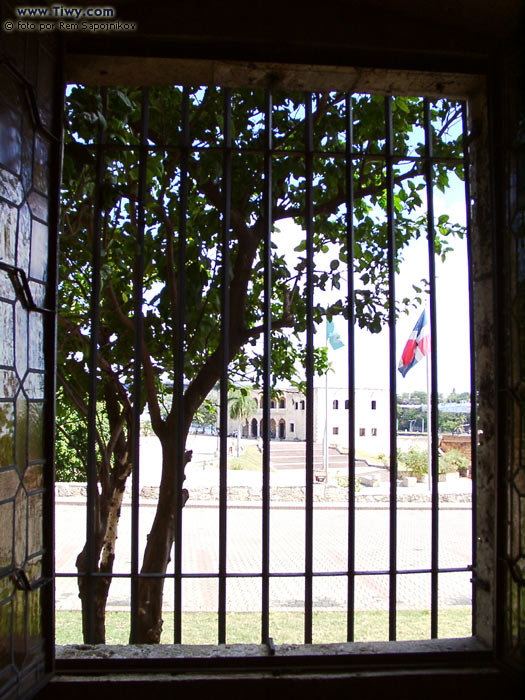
[{"xmin": 56, "ymin": 606, "xmax": 472, "ymax": 644}]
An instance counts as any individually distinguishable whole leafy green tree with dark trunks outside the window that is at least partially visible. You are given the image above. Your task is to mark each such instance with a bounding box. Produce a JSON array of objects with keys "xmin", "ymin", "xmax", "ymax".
[{"xmin": 58, "ymin": 87, "xmax": 462, "ymax": 643}]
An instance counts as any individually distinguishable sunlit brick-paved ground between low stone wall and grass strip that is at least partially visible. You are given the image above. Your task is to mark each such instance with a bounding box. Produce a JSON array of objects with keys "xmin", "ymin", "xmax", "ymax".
[{"xmin": 56, "ymin": 502, "xmax": 472, "ymax": 612}]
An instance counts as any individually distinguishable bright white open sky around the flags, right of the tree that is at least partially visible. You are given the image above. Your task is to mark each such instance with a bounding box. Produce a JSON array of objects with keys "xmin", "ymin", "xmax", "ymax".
[{"xmin": 274, "ymin": 172, "xmax": 470, "ymax": 394}]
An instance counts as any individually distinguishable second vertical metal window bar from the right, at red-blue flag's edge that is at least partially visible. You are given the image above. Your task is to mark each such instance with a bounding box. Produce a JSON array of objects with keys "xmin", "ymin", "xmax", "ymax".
[{"xmin": 423, "ymin": 98, "xmax": 439, "ymax": 639}]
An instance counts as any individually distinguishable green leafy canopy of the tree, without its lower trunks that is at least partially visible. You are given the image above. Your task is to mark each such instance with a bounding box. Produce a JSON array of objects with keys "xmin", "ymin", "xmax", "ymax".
[{"xmin": 60, "ymin": 86, "xmax": 462, "ymax": 410}]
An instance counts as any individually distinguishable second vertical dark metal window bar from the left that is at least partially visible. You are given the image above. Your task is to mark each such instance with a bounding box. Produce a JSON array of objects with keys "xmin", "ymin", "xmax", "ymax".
[{"xmin": 130, "ymin": 88, "xmax": 149, "ymax": 642}]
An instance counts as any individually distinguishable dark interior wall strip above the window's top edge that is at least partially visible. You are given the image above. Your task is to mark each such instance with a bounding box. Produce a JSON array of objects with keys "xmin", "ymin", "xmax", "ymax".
[{"xmin": 63, "ymin": 0, "xmax": 520, "ymax": 71}]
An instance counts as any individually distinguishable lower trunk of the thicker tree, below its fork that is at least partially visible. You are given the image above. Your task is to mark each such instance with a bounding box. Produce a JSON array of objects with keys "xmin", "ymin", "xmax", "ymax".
[{"xmin": 137, "ymin": 434, "xmax": 191, "ymax": 644}]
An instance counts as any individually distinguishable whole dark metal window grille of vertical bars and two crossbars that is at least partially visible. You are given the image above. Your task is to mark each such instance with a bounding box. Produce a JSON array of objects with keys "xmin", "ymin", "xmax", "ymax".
[{"xmin": 56, "ymin": 89, "xmax": 476, "ymax": 643}]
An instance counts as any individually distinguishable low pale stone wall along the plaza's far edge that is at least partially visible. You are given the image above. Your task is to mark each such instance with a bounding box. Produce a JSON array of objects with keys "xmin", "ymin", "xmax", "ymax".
[{"xmin": 55, "ymin": 482, "xmax": 472, "ymax": 504}]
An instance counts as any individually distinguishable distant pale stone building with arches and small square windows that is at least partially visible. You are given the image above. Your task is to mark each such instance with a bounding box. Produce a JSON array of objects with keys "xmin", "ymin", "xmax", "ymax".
[{"xmin": 228, "ymin": 387, "xmax": 390, "ymax": 453}]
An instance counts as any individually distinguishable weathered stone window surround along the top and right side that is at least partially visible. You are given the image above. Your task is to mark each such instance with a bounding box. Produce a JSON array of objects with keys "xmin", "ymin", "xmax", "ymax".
[{"xmin": 56, "ymin": 54, "xmax": 497, "ymax": 655}]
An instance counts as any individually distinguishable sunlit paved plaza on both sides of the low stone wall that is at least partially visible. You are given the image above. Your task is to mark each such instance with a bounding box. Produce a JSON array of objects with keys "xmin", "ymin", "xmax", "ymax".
[{"xmin": 56, "ymin": 436, "xmax": 472, "ymax": 612}]
